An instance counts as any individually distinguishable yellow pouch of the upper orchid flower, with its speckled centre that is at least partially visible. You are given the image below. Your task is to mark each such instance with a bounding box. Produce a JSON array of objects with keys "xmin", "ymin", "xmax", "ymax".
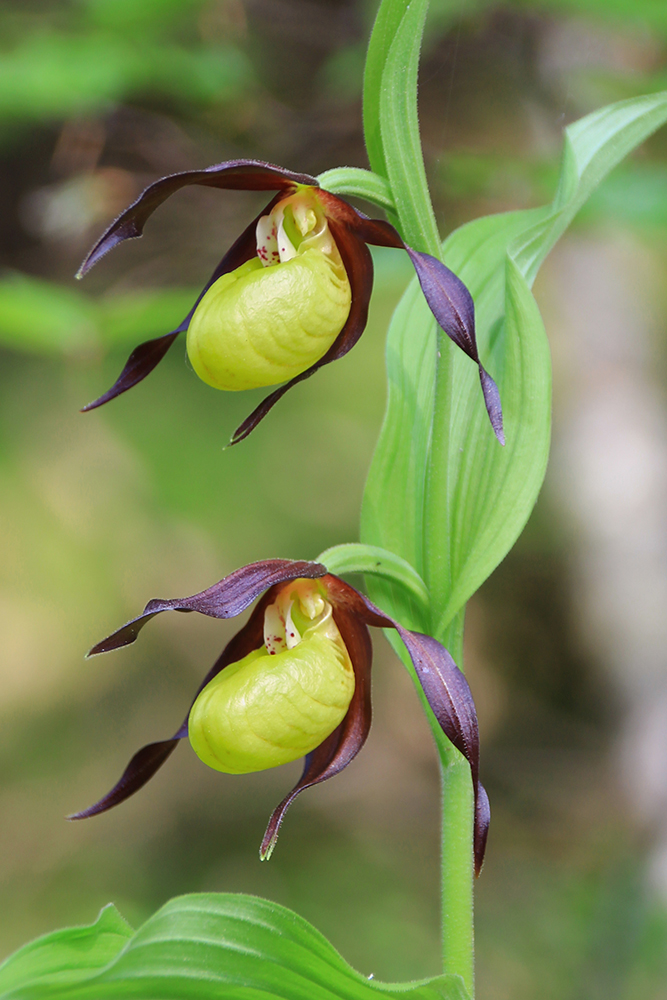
[{"xmin": 187, "ymin": 188, "xmax": 352, "ymax": 390}]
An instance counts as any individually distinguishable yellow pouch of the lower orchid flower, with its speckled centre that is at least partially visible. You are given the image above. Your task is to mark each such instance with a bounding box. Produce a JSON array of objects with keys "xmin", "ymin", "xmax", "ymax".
[{"xmin": 188, "ymin": 580, "xmax": 355, "ymax": 774}]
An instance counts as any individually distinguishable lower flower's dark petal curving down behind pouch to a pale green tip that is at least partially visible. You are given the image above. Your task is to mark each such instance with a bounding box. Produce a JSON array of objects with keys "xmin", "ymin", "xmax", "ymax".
[{"xmin": 259, "ymin": 607, "xmax": 373, "ymax": 861}]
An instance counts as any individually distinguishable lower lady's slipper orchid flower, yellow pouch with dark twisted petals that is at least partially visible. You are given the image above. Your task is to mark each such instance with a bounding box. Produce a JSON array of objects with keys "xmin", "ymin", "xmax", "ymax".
[{"xmin": 69, "ymin": 559, "xmax": 489, "ymax": 873}]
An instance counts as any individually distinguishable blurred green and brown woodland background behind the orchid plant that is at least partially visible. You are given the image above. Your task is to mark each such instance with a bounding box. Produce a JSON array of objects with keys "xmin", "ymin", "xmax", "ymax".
[{"xmin": 0, "ymin": 0, "xmax": 667, "ymax": 1000}]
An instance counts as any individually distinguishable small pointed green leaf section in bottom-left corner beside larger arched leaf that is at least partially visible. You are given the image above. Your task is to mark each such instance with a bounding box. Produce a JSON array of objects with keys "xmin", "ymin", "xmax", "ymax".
[{"xmin": 0, "ymin": 903, "xmax": 134, "ymax": 997}]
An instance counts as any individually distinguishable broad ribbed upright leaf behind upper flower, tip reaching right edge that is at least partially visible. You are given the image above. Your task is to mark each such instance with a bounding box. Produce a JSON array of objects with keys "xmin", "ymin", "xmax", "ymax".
[{"xmin": 361, "ymin": 93, "xmax": 667, "ymax": 637}]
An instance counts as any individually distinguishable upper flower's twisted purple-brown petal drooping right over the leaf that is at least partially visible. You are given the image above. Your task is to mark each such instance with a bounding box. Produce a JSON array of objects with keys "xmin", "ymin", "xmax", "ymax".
[{"xmin": 319, "ymin": 203, "xmax": 505, "ymax": 444}]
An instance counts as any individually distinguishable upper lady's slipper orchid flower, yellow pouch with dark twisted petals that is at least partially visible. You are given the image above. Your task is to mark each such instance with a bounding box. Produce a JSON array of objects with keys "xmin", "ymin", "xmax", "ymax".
[{"xmin": 77, "ymin": 160, "xmax": 504, "ymax": 444}]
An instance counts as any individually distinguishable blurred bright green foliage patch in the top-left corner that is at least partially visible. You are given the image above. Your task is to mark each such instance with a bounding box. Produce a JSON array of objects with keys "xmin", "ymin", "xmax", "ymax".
[{"xmin": 0, "ymin": 0, "xmax": 254, "ymax": 135}]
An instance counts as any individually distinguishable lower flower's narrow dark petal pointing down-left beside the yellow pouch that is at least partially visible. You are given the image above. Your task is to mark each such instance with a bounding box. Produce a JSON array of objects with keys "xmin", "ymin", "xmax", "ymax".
[{"xmin": 67, "ymin": 593, "xmax": 272, "ymax": 819}]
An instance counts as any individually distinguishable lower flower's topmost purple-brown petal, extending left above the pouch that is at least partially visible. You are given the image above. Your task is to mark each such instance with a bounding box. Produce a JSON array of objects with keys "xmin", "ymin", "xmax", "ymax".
[{"xmin": 88, "ymin": 559, "xmax": 327, "ymax": 656}]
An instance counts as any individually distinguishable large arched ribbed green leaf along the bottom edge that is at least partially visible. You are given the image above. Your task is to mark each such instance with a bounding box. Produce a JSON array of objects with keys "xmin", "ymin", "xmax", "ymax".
[{"xmin": 0, "ymin": 893, "xmax": 469, "ymax": 1000}]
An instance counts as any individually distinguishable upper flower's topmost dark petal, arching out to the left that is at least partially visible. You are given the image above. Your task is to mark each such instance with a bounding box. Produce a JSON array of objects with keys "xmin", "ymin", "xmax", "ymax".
[{"xmin": 77, "ymin": 160, "xmax": 317, "ymax": 278}]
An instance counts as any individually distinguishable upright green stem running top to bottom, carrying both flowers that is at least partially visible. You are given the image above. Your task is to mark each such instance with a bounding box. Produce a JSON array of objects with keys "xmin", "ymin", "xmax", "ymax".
[{"xmin": 364, "ymin": 0, "xmax": 474, "ymax": 997}]
